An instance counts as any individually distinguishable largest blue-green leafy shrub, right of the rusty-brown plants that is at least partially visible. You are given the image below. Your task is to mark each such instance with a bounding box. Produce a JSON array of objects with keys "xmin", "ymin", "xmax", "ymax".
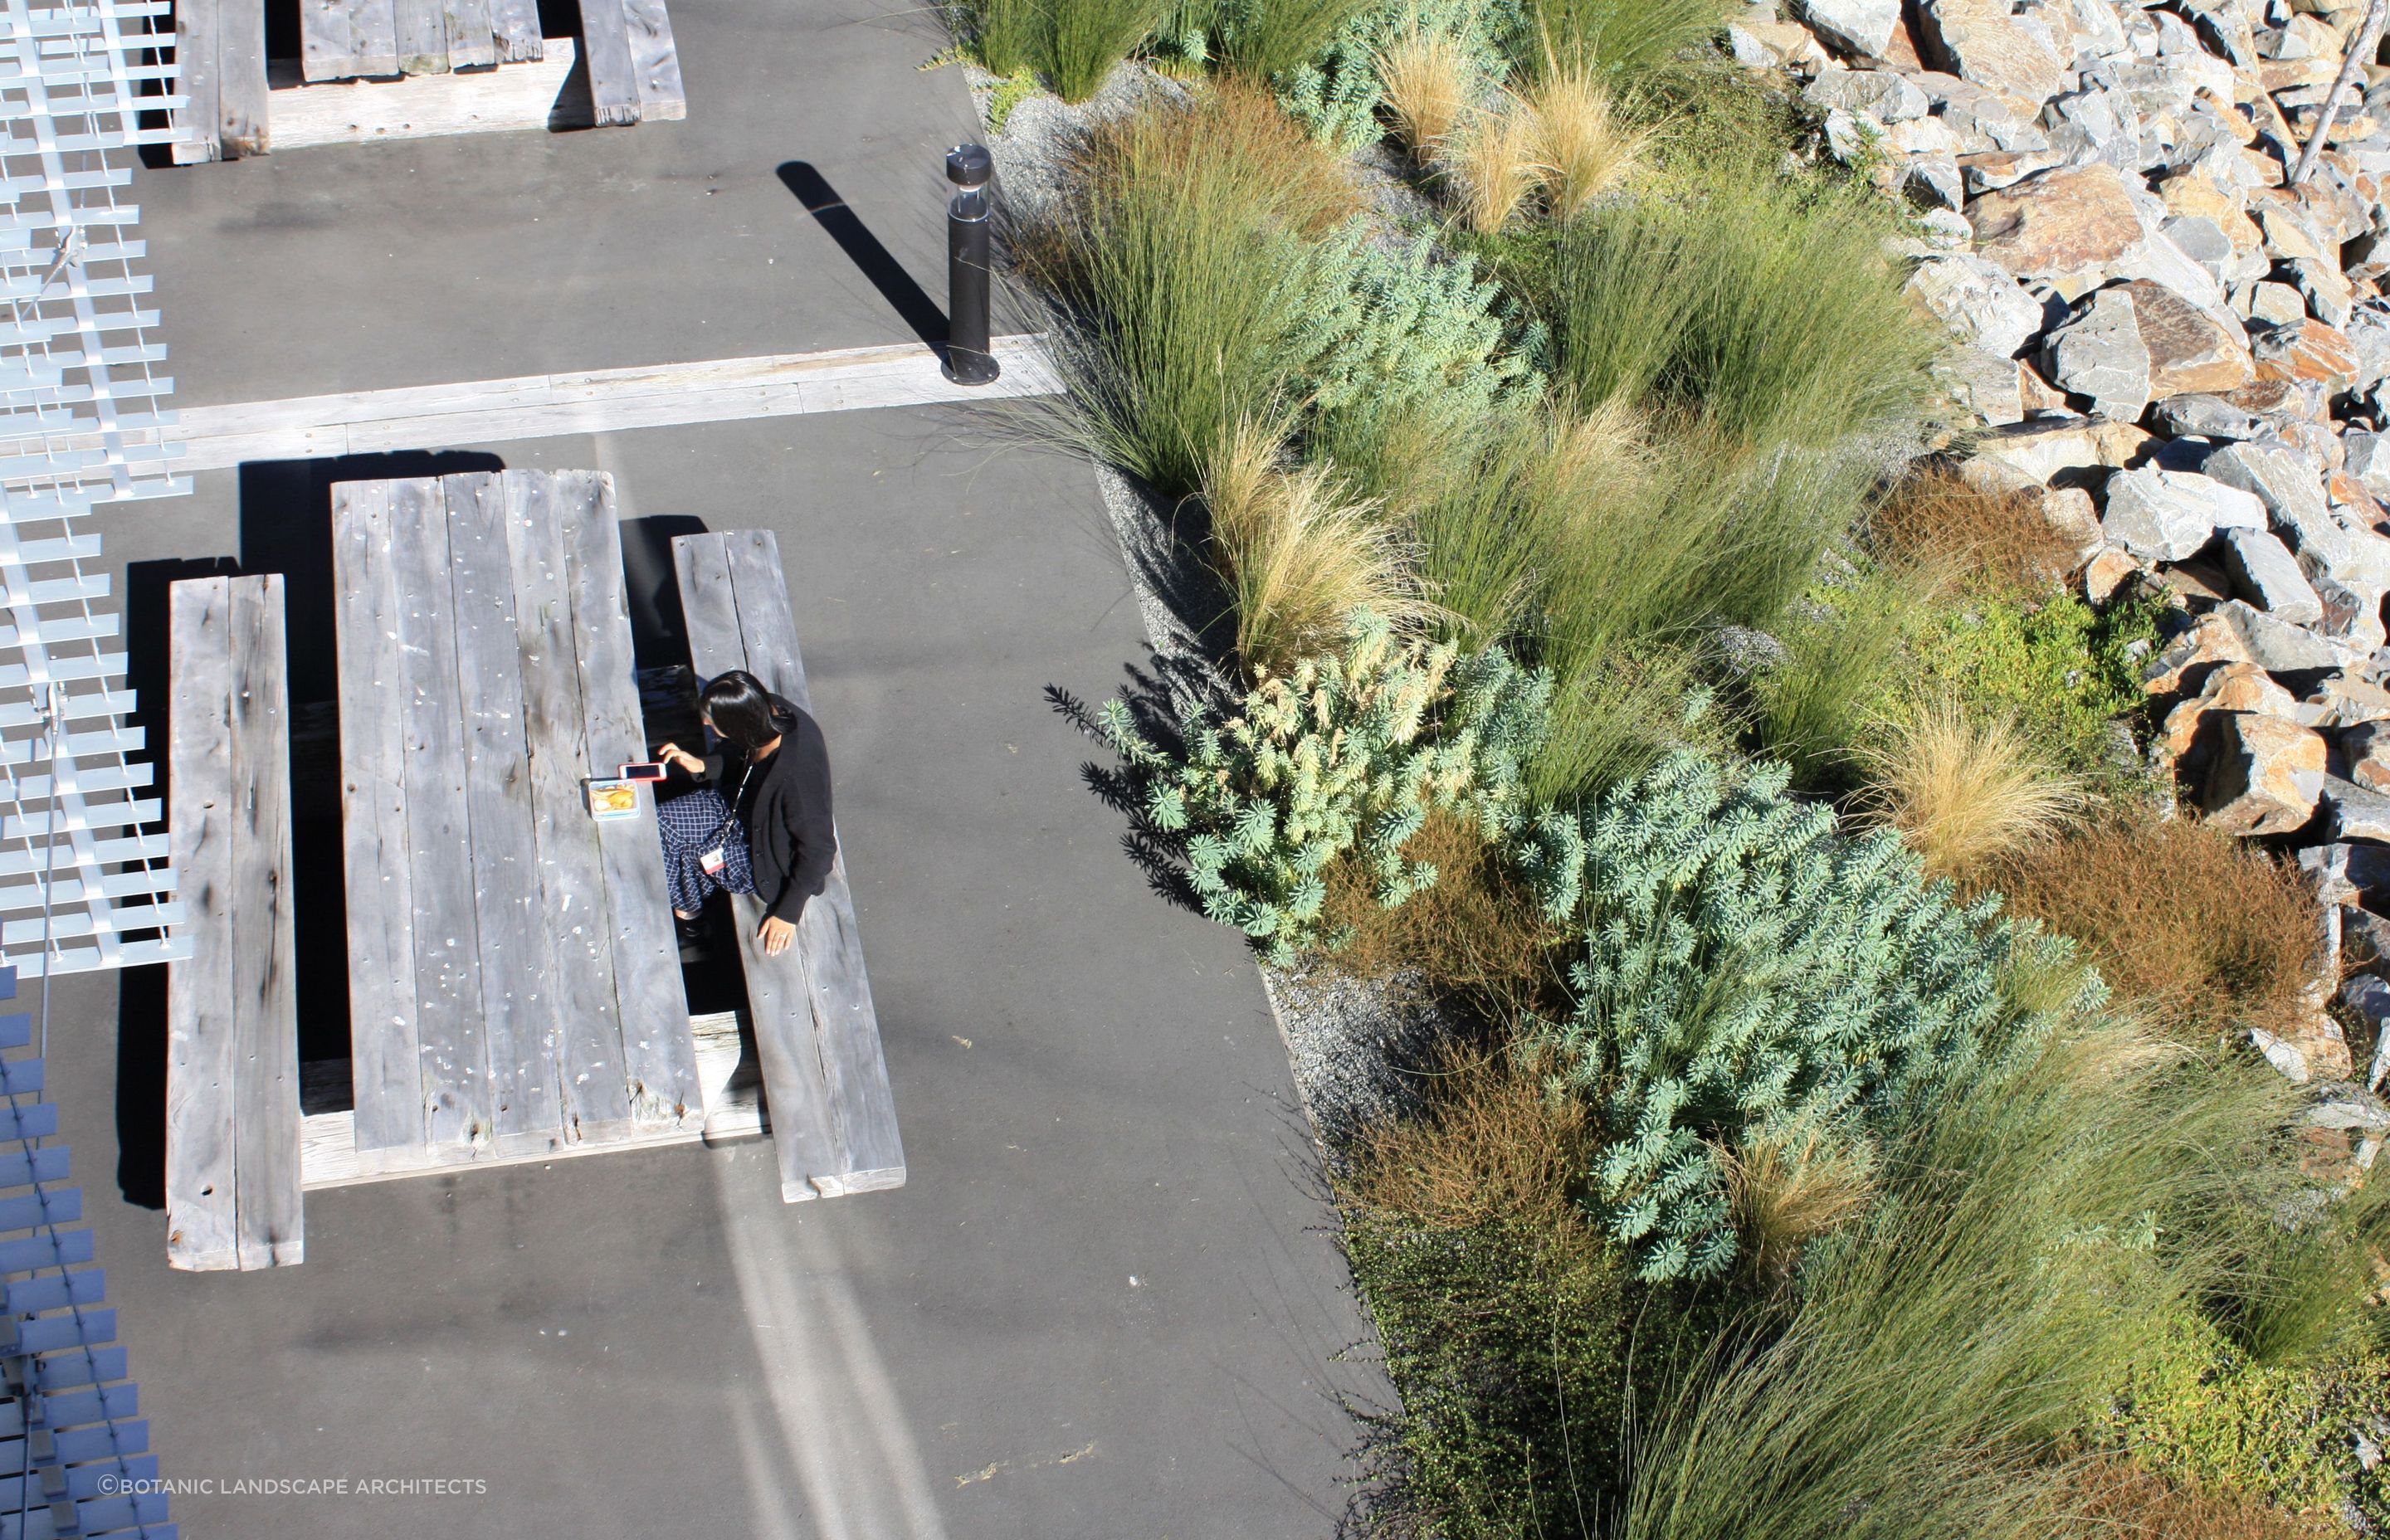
[{"xmin": 1518, "ymin": 753, "xmax": 2099, "ymax": 1279}]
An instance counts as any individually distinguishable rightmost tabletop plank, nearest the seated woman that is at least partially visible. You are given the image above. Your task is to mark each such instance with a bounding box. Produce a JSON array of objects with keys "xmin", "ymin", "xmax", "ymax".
[{"xmin": 557, "ymin": 471, "xmax": 705, "ymax": 1126}]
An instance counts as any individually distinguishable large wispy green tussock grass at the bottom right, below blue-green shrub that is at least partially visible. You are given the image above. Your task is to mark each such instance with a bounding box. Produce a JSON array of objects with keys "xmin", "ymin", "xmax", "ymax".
[{"xmin": 1616, "ymin": 1021, "xmax": 2290, "ymax": 1540}]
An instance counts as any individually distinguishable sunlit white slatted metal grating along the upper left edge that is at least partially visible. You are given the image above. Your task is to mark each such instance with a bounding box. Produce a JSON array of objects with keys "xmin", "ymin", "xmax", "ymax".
[{"xmin": 0, "ymin": 0, "xmax": 191, "ymax": 978}]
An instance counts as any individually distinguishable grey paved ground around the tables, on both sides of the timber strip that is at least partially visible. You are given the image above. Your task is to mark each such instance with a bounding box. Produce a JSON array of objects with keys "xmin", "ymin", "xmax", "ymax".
[{"xmin": 37, "ymin": 0, "xmax": 1382, "ymax": 1540}]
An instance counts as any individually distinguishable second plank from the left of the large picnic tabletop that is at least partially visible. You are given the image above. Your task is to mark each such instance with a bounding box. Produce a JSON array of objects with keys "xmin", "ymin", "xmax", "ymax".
[{"xmin": 389, "ymin": 478, "xmax": 495, "ymax": 1148}]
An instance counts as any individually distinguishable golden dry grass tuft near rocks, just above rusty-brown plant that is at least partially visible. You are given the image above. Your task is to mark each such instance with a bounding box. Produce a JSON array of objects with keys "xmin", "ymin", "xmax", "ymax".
[{"xmin": 1862, "ymin": 699, "xmax": 2084, "ymax": 880}]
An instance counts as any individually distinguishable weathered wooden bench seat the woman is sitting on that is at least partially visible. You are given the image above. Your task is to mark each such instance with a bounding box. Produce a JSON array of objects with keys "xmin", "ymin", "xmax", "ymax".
[{"xmin": 671, "ymin": 531, "xmax": 904, "ymax": 1203}]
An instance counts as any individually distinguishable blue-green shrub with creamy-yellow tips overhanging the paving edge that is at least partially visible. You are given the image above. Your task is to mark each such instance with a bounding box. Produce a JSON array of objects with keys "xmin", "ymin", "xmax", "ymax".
[{"xmin": 1100, "ymin": 610, "xmax": 1551, "ymax": 966}]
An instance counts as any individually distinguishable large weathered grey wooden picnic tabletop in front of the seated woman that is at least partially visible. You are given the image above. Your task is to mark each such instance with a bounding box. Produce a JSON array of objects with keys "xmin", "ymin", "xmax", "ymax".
[{"xmin": 332, "ymin": 471, "xmax": 705, "ymax": 1177}]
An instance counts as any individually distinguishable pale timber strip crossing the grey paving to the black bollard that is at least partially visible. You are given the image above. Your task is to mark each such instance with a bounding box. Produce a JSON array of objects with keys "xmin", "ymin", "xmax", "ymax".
[{"xmin": 155, "ymin": 334, "xmax": 1061, "ymax": 471}]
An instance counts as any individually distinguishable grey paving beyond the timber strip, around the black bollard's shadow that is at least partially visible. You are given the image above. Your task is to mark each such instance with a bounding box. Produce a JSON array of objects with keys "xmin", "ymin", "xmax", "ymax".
[{"xmin": 134, "ymin": 0, "xmax": 1002, "ymax": 404}]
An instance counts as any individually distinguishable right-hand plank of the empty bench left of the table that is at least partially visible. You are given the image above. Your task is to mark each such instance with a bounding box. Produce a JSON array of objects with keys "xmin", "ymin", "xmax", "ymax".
[{"xmin": 229, "ymin": 574, "xmax": 306, "ymax": 1267}]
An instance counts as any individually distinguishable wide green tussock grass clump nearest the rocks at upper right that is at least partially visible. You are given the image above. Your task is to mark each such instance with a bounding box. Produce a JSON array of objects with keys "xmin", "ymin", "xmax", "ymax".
[{"xmin": 1546, "ymin": 168, "xmax": 1941, "ymax": 450}]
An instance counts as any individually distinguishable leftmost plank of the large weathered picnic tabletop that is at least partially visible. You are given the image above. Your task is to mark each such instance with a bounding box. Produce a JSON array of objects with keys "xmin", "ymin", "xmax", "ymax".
[{"xmin": 332, "ymin": 480, "xmax": 426, "ymax": 1169}]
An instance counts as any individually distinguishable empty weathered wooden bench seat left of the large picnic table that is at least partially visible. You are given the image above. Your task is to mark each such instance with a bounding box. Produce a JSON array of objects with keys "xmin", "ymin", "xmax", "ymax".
[{"xmin": 165, "ymin": 577, "xmax": 304, "ymax": 1270}]
